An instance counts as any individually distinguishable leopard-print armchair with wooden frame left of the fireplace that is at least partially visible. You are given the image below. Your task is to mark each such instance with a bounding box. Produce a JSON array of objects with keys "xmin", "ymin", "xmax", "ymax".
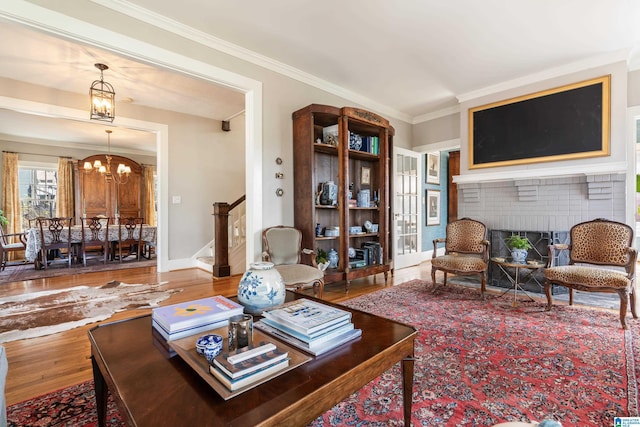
[{"xmin": 431, "ymin": 218, "xmax": 489, "ymax": 298}]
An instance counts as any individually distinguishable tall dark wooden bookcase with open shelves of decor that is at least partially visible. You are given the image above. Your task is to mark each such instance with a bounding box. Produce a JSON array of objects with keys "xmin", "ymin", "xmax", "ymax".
[{"xmin": 293, "ymin": 104, "xmax": 394, "ymax": 290}]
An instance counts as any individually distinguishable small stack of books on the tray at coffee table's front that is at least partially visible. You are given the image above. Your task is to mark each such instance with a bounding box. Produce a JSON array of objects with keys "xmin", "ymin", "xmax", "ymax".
[{"xmin": 209, "ymin": 341, "xmax": 289, "ymax": 391}]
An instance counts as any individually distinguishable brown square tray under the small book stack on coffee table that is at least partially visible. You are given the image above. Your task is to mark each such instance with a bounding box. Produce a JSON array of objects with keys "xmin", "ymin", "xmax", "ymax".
[{"xmin": 169, "ymin": 327, "xmax": 312, "ymax": 400}]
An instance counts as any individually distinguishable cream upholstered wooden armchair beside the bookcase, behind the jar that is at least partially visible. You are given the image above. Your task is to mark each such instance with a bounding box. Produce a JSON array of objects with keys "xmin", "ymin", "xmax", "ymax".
[{"xmin": 262, "ymin": 226, "xmax": 324, "ymax": 298}]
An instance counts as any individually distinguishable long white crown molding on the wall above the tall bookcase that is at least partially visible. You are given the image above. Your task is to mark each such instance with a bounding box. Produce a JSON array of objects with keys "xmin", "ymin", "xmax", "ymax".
[{"xmin": 90, "ymin": 0, "xmax": 412, "ymax": 123}]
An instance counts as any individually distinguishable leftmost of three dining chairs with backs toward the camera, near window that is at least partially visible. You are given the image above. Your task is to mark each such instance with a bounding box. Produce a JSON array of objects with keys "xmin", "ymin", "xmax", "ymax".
[{"xmin": 36, "ymin": 217, "xmax": 73, "ymax": 270}]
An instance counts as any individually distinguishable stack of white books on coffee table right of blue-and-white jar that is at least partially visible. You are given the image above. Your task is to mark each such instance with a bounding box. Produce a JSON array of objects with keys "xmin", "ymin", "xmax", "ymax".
[{"xmin": 254, "ymin": 299, "xmax": 362, "ymax": 356}]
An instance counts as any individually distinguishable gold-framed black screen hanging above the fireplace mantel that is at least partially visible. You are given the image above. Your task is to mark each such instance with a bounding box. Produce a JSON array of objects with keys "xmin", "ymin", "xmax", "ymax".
[{"xmin": 469, "ymin": 75, "xmax": 611, "ymax": 169}]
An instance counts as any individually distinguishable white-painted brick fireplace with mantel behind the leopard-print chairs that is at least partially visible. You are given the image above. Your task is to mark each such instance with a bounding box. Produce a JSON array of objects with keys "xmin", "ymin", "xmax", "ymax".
[{"xmin": 458, "ymin": 173, "xmax": 626, "ymax": 293}]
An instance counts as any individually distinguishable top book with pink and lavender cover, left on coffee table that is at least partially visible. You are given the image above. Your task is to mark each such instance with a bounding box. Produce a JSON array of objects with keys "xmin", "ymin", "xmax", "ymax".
[{"xmin": 151, "ymin": 295, "xmax": 244, "ymax": 334}]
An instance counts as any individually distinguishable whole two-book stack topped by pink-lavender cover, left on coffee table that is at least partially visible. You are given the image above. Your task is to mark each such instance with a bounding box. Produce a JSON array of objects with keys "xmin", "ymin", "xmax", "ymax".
[{"xmin": 151, "ymin": 295, "xmax": 244, "ymax": 341}]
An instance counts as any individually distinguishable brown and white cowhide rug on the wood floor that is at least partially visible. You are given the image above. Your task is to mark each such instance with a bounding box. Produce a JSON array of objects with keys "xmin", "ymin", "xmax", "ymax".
[{"xmin": 0, "ymin": 281, "xmax": 182, "ymax": 343}]
